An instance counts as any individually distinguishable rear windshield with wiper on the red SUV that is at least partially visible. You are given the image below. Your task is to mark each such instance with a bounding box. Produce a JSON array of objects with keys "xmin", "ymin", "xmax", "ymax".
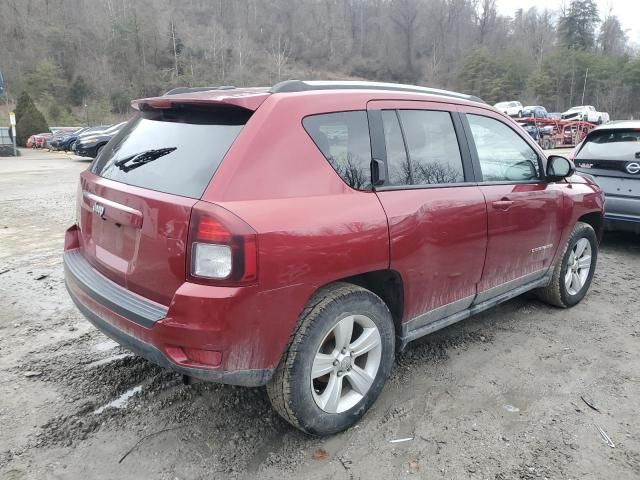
[{"xmin": 91, "ymin": 107, "xmax": 252, "ymax": 198}]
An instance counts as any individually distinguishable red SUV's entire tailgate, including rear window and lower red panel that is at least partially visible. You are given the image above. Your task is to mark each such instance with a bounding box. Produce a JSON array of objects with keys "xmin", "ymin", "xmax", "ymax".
[{"xmin": 77, "ymin": 105, "xmax": 252, "ymax": 305}]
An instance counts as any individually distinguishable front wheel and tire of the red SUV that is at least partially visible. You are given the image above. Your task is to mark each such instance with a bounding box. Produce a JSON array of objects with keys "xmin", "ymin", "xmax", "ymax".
[{"xmin": 537, "ymin": 222, "xmax": 598, "ymax": 308}]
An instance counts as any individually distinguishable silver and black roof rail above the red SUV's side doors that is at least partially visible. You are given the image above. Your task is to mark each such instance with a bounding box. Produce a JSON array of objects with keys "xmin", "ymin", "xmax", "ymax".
[{"xmin": 269, "ymin": 80, "xmax": 485, "ymax": 103}]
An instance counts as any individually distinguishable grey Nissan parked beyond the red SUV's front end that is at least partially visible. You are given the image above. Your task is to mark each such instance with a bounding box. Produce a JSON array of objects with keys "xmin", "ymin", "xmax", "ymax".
[{"xmin": 573, "ymin": 121, "xmax": 640, "ymax": 233}]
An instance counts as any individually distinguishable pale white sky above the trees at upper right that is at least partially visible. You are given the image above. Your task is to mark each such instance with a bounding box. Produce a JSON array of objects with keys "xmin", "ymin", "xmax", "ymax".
[{"xmin": 497, "ymin": 0, "xmax": 640, "ymax": 45}]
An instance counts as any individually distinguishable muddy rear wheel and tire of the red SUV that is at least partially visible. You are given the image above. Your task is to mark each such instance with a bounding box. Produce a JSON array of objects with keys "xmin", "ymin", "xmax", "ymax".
[{"xmin": 267, "ymin": 283, "xmax": 395, "ymax": 435}]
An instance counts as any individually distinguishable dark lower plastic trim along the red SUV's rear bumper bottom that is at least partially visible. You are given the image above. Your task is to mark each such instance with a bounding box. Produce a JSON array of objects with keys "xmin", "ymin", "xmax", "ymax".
[{"xmin": 65, "ymin": 279, "xmax": 273, "ymax": 387}]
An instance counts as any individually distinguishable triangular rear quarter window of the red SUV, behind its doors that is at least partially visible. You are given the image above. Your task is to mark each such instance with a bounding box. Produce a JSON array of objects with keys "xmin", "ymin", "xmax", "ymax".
[{"xmin": 302, "ymin": 111, "xmax": 371, "ymax": 190}]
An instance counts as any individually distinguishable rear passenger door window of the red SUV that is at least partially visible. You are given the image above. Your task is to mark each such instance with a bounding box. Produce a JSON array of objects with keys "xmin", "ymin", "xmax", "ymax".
[{"xmin": 383, "ymin": 110, "xmax": 464, "ymax": 185}]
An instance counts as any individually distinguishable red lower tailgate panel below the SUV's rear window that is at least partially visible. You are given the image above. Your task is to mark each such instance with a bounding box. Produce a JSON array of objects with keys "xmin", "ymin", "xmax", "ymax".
[{"xmin": 78, "ymin": 171, "xmax": 197, "ymax": 305}]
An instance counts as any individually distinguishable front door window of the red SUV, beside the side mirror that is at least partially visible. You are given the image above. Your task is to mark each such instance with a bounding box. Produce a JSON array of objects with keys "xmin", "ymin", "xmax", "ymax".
[{"xmin": 467, "ymin": 115, "xmax": 540, "ymax": 182}]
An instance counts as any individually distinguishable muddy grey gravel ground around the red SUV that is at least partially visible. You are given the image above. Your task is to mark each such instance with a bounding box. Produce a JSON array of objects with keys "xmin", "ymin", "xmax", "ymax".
[{"xmin": 0, "ymin": 151, "xmax": 640, "ymax": 480}]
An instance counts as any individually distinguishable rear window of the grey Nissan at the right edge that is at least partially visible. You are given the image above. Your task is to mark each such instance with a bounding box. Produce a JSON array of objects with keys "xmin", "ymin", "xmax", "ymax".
[{"xmin": 575, "ymin": 130, "xmax": 640, "ymax": 160}]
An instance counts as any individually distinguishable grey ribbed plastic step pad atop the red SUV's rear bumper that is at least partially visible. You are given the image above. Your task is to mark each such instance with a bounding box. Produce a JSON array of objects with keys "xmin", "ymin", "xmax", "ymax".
[{"xmin": 63, "ymin": 249, "xmax": 169, "ymax": 328}]
